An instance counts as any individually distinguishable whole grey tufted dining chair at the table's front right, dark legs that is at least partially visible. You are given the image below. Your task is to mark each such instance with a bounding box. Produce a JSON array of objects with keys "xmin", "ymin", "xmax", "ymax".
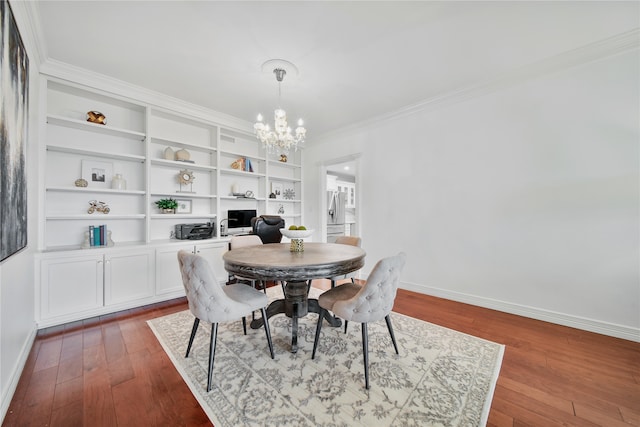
[{"xmin": 311, "ymin": 252, "xmax": 406, "ymax": 389}]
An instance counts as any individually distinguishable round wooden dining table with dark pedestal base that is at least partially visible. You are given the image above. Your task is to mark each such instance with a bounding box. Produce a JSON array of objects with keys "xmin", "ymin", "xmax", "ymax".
[{"xmin": 223, "ymin": 242, "xmax": 366, "ymax": 353}]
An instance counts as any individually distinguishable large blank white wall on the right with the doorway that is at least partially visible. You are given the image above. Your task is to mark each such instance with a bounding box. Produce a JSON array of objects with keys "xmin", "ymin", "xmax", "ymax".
[{"xmin": 304, "ymin": 50, "xmax": 640, "ymax": 341}]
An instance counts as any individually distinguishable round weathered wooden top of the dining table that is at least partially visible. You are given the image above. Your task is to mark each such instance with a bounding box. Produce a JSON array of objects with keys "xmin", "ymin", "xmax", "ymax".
[{"xmin": 223, "ymin": 242, "xmax": 366, "ymax": 281}]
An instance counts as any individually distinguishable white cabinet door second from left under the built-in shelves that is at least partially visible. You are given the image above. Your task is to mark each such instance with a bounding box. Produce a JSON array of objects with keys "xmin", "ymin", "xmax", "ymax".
[{"xmin": 104, "ymin": 249, "xmax": 155, "ymax": 305}]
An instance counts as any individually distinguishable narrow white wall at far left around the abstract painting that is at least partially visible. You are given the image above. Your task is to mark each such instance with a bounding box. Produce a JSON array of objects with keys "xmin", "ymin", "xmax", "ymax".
[{"xmin": 0, "ymin": 2, "xmax": 39, "ymax": 420}]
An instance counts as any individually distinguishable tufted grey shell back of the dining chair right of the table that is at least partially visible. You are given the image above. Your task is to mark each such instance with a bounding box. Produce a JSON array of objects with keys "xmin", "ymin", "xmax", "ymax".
[{"xmin": 333, "ymin": 252, "xmax": 406, "ymax": 323}]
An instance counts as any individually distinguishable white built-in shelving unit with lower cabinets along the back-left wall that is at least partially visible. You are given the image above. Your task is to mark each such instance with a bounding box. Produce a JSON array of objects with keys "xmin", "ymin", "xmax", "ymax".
[{"xmin": 35, "ymin": 75, "xmax": 303, "ymax": 326}]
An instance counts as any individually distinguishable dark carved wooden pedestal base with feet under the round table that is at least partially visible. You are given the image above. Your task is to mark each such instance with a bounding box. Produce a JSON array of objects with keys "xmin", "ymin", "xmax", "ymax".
[{"xmin": 251, "ymin": 282, "xmax": 342, "ymax": 353}]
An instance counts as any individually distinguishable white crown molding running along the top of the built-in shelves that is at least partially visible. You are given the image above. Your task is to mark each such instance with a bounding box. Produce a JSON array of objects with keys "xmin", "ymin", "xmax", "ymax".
[{"xmin": 40, "ymin": 59, "xmax": 253, "ymax": 133}]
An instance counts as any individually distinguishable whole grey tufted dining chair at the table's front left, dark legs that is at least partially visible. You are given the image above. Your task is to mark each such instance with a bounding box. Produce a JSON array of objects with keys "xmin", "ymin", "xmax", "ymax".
[{"xmin": 178, "ymin": 251, "xmax": 274, "ymax": 392}]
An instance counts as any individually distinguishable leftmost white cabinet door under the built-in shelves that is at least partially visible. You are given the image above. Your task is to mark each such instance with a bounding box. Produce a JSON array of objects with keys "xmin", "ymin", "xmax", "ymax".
[{"xmin": 40, "ymin": 254, "xmax": 103, "ymax": 319}]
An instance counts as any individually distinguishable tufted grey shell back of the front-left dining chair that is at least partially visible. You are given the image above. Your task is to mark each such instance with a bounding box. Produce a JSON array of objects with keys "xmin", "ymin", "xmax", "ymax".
[{"xmin": 178, "ymin": 251, "xmax": 251, "ymax": 323}]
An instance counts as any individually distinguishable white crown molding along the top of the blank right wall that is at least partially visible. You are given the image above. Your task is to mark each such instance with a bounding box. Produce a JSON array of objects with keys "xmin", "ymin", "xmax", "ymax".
[{"xmin": 314, "ymin": 28, "xmax": 640, "ymax": 144}]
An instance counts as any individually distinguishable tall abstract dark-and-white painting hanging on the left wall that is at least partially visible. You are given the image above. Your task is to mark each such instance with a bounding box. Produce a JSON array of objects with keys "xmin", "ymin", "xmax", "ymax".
[{"xmin": 0, "ymin": 0, "xmax": 29, "ymax": 261}]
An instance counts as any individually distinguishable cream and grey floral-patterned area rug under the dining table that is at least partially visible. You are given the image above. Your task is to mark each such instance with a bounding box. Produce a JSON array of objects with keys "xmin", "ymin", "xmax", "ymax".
[{"xmin": 148, "ymin": 287, "xmax": 504, "ymax": 427}]
